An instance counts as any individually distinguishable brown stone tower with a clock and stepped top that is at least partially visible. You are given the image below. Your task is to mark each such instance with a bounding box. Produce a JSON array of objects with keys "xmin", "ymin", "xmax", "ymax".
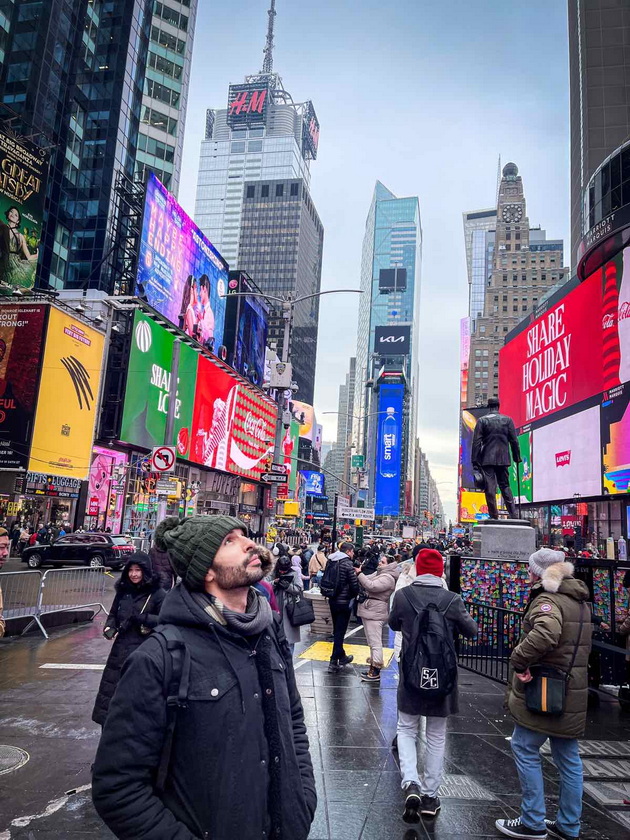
[{"xmin": 467, "ymin": 163, "xmax": 569, "ymax": 407}]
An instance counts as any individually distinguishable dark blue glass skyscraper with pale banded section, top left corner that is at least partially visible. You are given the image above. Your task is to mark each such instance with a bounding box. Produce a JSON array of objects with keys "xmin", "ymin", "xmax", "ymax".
[{"xmin": 0, "ymin": 0, "xmax": 196, "ymax": 292}]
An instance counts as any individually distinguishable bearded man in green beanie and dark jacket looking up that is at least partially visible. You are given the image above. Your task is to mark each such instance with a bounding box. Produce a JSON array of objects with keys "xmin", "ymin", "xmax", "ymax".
[{"xmin": 92, "ymin": 516, "xmax": 317, "ymax": 840}]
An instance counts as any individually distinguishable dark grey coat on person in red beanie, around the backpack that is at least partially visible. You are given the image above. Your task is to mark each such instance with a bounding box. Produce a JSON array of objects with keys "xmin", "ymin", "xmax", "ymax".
[{"xmin": 388, "ymin": 575, "xmax": 477, "ymax": 717}]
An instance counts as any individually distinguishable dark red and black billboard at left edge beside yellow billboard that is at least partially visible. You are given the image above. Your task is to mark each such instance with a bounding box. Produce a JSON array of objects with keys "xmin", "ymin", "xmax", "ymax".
[{"xmin": 0, "ymin": 303, "xmax": 47, "ymax": 470}]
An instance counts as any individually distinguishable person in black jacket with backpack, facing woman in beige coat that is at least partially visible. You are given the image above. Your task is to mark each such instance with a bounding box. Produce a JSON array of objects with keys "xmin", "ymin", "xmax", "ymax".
[{"xmin": 319, "ymin": 542, "xmax": 359, "ymax": 674}]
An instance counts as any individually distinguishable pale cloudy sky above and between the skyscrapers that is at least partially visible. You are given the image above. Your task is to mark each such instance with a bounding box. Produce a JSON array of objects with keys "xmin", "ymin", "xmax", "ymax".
[{"xmin": 179, "ymin": 0, "xmax": 570, "ymax": 520}]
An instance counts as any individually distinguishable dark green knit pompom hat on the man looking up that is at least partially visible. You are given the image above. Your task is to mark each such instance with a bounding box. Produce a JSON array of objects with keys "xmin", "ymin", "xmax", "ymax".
[{"xmin": 155, "ymin": 515, "xmax": 248, "ymax": 590}]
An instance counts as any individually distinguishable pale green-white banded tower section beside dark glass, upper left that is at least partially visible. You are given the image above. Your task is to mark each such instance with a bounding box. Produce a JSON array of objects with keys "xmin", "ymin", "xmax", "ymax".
[{"xmin": 135, "ymin": 0, "xmax": 197, "ymax": 196}]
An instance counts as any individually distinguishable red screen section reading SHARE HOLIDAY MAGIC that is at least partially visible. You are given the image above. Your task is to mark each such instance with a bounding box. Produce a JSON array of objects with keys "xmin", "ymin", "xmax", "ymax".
[{"xmin": 499, "ymin": 271, "xmax": 604, "ymax": 429}]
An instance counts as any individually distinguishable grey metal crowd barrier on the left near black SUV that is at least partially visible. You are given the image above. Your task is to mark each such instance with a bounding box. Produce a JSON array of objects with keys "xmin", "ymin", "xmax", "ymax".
[{"xmin": 0, "ymin": 568, "xmax": 107, "ymax": 639}]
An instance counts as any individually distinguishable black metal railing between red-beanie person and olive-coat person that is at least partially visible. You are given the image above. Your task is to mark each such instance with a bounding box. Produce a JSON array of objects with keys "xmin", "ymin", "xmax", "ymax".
[{"xmin": 458, "ymin": 602, "xmax": 523, "ymax": 683}]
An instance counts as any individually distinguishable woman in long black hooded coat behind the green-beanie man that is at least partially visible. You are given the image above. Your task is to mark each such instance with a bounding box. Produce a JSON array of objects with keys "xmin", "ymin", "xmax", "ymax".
[{"xmin": 92, "ymin": 551, "xmax": 166, "ymax": 726}]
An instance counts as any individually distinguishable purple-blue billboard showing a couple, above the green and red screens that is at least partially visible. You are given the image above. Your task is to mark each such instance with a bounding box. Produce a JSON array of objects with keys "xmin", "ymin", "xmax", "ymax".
[{"xmin": 136, "ymin": 173, "xmax": 228, "ymax": 354}]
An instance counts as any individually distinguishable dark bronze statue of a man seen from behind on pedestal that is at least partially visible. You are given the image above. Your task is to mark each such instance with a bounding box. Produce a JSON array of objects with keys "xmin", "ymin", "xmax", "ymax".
[{"xmin": 471, "ymin": 397, "xmax": 522, "ymax": 519}]
